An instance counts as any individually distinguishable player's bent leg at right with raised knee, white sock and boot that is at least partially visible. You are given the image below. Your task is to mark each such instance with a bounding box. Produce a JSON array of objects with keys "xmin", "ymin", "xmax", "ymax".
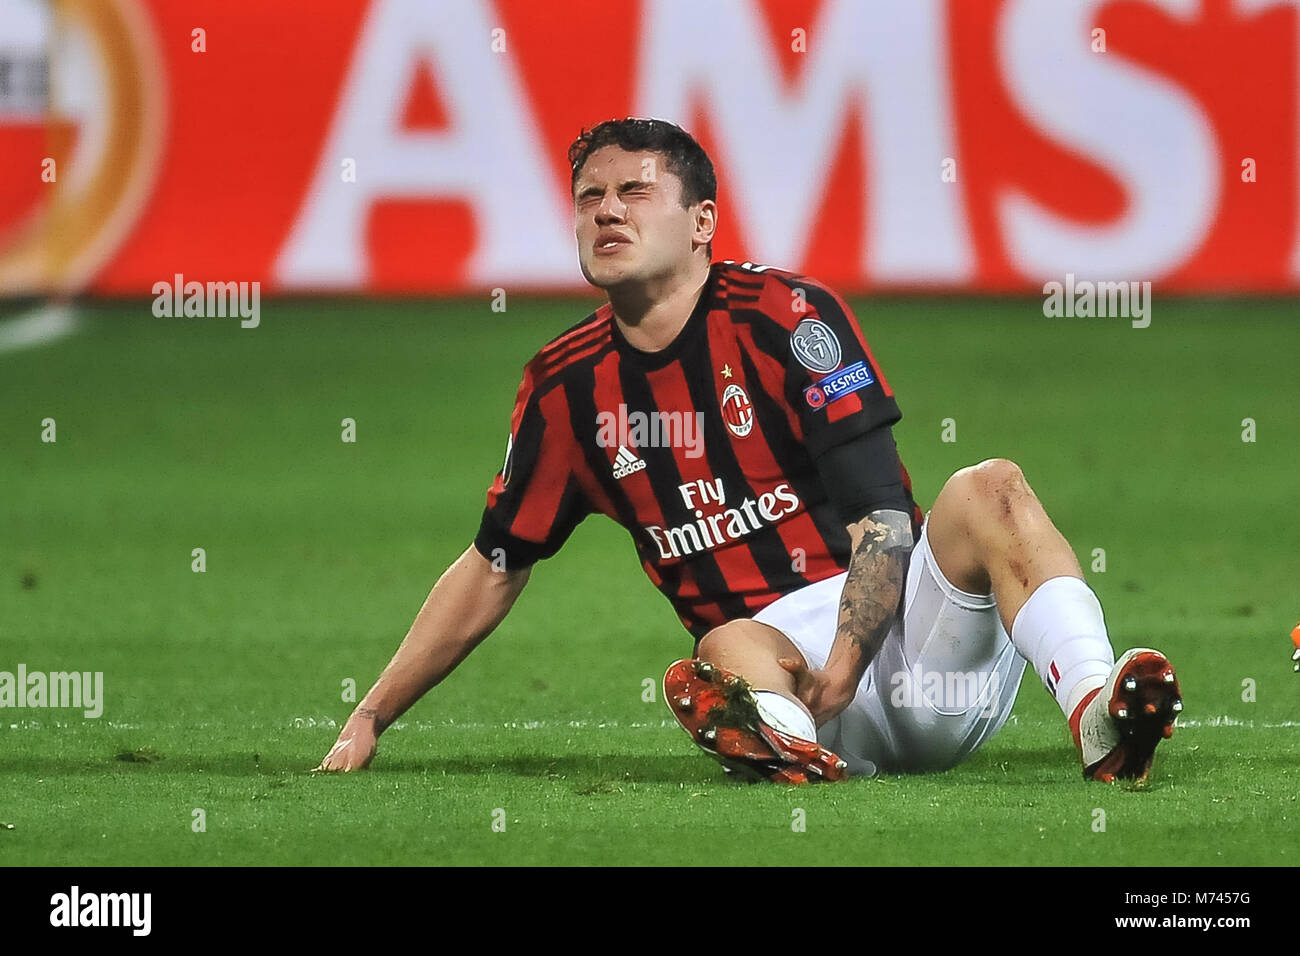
[{"xmin": 926, "ymin": 458, "xmax": 1183, "ymax": 782}]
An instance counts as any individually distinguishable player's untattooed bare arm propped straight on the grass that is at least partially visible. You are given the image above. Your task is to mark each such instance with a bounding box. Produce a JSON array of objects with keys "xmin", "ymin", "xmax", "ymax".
[{"xmin": 316, "ymin": 546, "xmax": 529, "ymax": 771}]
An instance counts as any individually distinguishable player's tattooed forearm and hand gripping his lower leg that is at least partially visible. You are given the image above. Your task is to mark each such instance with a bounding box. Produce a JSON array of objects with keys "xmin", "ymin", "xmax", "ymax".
[{"xmin": 783, "ymin": 510, "xmax": 913, "ymax": 726}]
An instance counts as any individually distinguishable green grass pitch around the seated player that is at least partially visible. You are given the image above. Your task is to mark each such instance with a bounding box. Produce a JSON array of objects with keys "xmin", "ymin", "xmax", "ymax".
[{"xmin": 0, "ymin": 298, "xmax": 1300, "ymax": 865}]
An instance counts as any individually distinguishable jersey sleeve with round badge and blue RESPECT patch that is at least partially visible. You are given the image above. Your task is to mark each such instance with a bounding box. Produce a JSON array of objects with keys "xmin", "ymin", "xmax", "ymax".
[{"xmin": 785, "ymin": 278, "xmax": 902, "ymax": 457}]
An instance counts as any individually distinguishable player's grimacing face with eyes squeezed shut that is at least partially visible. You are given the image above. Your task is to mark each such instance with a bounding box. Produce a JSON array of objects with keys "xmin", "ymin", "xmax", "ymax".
[{"xmin": 573, "ymin": 146, "xmax": 701, "ymax": 289}]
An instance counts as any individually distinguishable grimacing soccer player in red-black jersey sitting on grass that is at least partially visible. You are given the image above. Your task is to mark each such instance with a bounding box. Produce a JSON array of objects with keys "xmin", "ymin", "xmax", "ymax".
[{"xmin": 320, "ymin": 118, "xmax": 1182, "ymax": 783}]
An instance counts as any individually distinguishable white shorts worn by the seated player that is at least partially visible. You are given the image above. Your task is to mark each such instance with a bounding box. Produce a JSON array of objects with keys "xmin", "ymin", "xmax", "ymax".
[{"xmin": 754, "ymin": 515, "xmax": 1026, "ymax": 775}]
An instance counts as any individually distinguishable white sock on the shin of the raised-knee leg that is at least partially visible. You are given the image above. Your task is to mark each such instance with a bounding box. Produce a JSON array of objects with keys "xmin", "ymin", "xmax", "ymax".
[{"xmin": 1011, "ymin": 578, "xmax": 1115, "ymax": 719}]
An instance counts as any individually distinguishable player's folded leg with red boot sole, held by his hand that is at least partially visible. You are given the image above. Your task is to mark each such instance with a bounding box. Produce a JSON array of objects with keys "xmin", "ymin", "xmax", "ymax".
[{"xmin": 663, "ymin": 620, "xmax": 846, "ymax": 783}]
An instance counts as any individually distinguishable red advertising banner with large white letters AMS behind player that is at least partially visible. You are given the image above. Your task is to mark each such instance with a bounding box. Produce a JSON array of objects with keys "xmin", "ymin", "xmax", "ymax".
[{"xmin": 0, "ymin": 0, "xmax": 1300, "ymax": 295}]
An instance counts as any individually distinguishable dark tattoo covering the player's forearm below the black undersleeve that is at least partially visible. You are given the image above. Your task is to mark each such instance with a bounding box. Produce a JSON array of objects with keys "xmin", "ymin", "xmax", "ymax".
[{"xmin": 839, "ymin": 511, "xmax": 913, "ymax": 670}]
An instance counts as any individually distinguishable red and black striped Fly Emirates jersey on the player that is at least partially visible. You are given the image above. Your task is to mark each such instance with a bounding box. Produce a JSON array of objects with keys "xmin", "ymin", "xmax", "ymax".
[{"xmin": 475, "ymin": 261, "xmax": 922, "ymax": 639}]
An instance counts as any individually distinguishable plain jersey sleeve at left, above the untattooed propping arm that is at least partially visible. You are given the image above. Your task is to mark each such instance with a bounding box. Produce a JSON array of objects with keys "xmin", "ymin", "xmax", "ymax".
[{"xmin": 475, "ymin": 372, "xmax": 590, "ymax": 568}]
